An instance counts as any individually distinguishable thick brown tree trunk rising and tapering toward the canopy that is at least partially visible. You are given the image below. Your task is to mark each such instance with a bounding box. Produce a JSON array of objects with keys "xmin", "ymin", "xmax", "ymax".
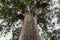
[{"xmin": 19, "ymin": 12, "xmax": 39, "ymax": 40}]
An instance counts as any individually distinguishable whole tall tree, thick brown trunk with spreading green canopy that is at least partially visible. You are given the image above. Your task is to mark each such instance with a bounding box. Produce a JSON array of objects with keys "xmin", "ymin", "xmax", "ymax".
[{"xmin": 0, "ymin": 0, "xmax": 58, "ymax": 40}]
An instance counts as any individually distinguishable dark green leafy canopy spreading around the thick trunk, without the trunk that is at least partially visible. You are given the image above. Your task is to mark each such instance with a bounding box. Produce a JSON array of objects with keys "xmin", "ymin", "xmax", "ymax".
[{"xmin": 0, "ymin": 0, "xmax": 60, "ymax": 40}]
